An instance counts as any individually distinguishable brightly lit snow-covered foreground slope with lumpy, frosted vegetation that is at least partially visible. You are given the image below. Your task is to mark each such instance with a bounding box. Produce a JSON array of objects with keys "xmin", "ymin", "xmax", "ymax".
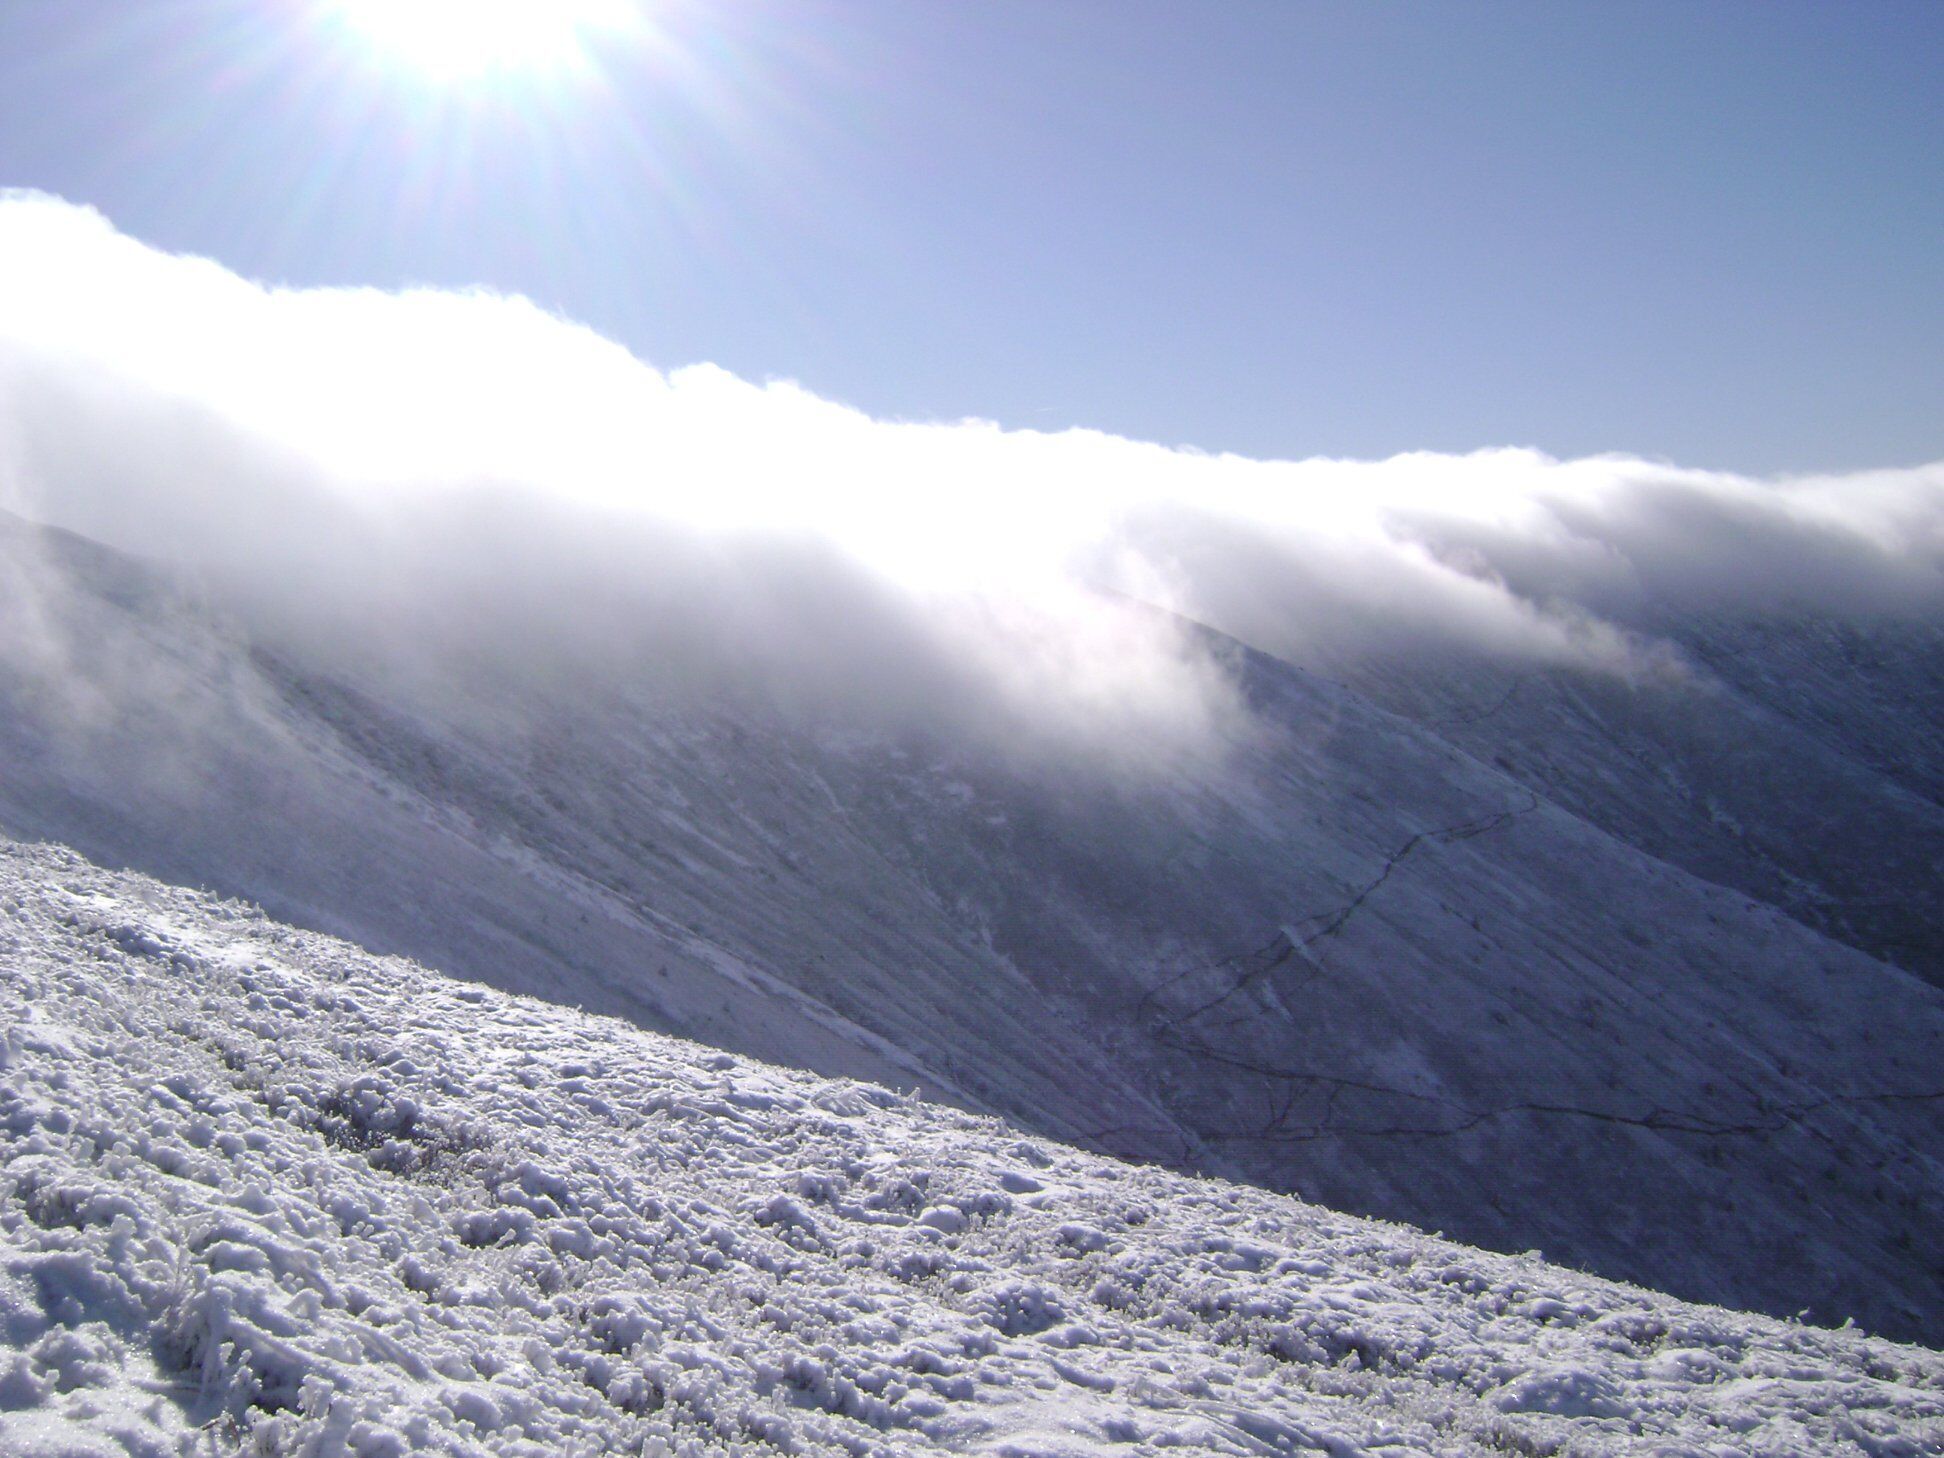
[{"xmin": 0, "ymin": 844, "xmax": 1944, "ymax": 1458}]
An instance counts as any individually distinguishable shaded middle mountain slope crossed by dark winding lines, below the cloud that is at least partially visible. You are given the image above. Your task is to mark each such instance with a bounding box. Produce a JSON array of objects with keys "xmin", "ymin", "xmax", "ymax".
[{"xmin": 0, "ymin": 513, "xmax": 1944, "ymax": 1339}]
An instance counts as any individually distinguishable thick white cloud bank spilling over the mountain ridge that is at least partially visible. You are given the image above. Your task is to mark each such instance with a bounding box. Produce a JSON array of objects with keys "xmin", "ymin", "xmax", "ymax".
[{"xmin": 0, "ymin": 194, "xmax": 1944, "ymax": 765}]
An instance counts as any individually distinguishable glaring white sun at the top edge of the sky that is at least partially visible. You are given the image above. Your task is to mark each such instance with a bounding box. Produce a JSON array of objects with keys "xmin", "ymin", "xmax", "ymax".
[{"xmin": 327, "ymin": 0, "xmax": 640, "ymax": 82}]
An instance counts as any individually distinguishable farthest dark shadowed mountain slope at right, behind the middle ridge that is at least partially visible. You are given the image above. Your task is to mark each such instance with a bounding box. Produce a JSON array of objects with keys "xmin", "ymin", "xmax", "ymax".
[{"xmin": 1337, "ymin": 612, "xmax": 1944, "ymax": 984}]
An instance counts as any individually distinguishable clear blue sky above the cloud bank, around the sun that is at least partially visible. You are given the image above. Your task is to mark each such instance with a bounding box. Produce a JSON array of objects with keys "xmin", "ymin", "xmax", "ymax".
[{"xmin": 0, "ymin": 0, "xmax": 1944, "ymax": 470}]
